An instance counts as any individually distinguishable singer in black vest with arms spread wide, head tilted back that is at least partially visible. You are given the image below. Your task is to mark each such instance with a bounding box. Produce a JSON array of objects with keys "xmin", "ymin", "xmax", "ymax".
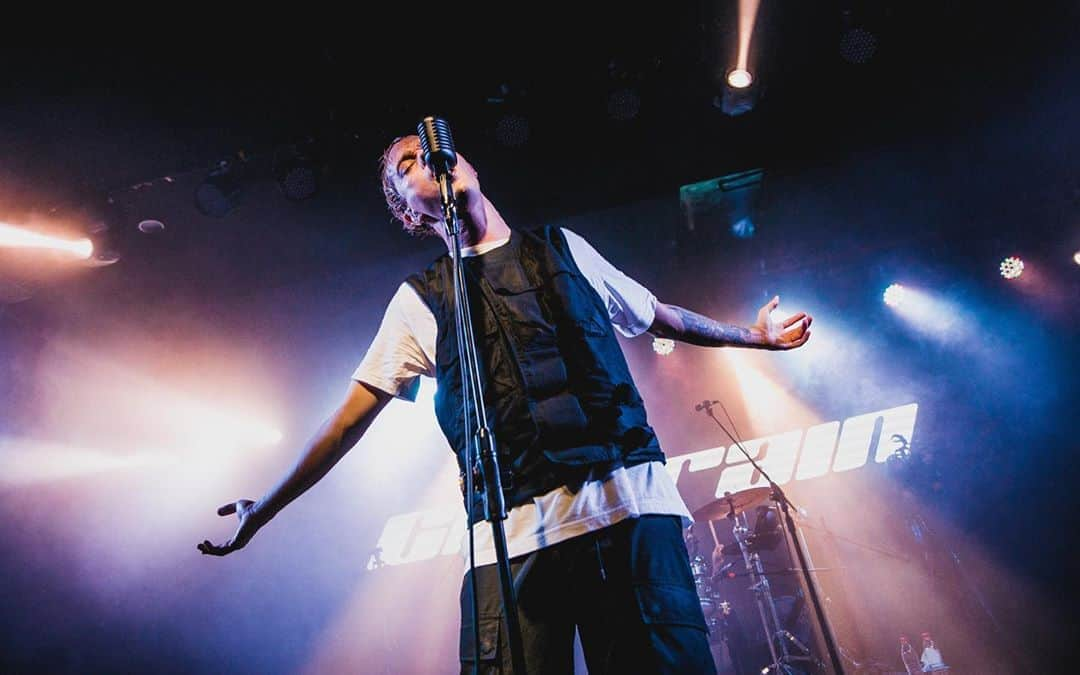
[{"xmin": 199, "ymin": 127, "xmax": 811, "ymax": 674}]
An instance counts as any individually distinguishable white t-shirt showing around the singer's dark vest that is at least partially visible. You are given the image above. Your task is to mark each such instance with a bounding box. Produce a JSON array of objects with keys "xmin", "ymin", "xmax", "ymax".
[{"xmin": 352, "ymin": 229, "xmax": 690, "ymax": 565}]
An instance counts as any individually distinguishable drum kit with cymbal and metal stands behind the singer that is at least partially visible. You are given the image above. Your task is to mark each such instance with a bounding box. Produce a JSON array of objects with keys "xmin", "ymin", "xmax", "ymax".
[{"xmin": 685, "ymin": 487, "xmax": 822, "ymax": 675}]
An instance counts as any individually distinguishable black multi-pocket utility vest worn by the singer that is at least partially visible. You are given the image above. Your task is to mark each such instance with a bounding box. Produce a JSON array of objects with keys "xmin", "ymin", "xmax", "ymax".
[{"xmin": 407, "ymin": 227, "xmax": 664, "ymax": 519}]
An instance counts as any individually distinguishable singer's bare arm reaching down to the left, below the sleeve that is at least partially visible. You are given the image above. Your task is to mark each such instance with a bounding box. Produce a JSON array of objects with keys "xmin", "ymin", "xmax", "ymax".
[{"xmin": 198, "ymin": 382, "xmax": 392, "ymax": 555}]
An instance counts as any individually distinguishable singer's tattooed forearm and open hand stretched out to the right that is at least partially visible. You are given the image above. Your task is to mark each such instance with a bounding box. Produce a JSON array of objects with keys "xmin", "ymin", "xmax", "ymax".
[{"xmin": 649, "ymin": 296, "xmax": 813, "ymax": 349}]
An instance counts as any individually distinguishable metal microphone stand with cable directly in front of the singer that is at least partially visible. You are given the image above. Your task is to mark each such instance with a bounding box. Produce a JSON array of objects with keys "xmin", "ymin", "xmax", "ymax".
[{"xmin": 437, "ymin": 171, "xmax": 526, "ymax": 675}]
